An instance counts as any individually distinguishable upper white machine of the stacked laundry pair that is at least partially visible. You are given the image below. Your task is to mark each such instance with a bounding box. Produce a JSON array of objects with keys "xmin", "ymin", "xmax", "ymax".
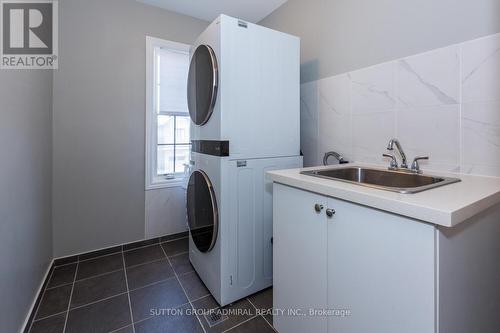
[{"xmin": 188, "ymin": 15, "xmax": 300, "ymax": 159}]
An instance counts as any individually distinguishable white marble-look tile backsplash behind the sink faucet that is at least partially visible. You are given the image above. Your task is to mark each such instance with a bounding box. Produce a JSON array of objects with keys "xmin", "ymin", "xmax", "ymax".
[{"xmin": 301, "ymin": 34, "xmax": 500, "ymax": 177}]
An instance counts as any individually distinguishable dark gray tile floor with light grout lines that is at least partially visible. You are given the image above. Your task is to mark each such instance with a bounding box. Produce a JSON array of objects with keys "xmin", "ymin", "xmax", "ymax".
[{"xmin": 26, "ymin": 238, "xmax": 274, "ymax": 333}]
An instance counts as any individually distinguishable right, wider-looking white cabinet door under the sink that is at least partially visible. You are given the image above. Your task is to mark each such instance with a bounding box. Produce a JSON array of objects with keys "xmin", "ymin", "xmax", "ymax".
[{"xmin": 328, "ymin": 199, "xmax": 435, "ymax": 333}]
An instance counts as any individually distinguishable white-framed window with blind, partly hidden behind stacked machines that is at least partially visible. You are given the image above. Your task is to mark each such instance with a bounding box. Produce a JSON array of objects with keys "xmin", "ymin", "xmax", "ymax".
[{"xmin": 146, "ymin": 37, "xmax": 191, "ymax": 189}]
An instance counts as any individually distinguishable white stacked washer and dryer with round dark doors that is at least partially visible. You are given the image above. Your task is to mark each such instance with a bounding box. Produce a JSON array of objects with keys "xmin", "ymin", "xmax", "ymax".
[{"xmin": 186, "ymin": 15, "xmax": 302, "ymax": 305}]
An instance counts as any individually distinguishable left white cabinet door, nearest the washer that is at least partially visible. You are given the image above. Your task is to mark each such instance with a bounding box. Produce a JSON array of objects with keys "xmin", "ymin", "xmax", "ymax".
[{"xmin": 273, "ymin": 183, "xmax": 327, "ymax": 333}]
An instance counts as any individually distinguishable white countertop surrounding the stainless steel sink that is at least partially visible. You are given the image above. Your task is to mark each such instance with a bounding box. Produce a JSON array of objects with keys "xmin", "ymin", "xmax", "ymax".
[{"xmin": 267, "ymin": 163, "xmax": 500, "ymax": 227}]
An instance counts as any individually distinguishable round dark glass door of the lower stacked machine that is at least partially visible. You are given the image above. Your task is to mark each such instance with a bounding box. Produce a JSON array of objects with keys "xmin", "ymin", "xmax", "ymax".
[{"xmin": 187, "ymin": 170, "xmax": 219, "ymax": 252}]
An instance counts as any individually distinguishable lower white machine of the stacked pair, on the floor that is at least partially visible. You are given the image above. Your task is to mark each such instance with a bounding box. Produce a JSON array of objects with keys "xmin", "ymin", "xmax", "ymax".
[{"xmin": 187, "ymin": 153, "xmax": 302, "ymax": 306}]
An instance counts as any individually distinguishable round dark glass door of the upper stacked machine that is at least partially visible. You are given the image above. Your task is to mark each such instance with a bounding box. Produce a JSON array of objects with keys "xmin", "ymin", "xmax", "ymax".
[{"xmin": 187, "ymin": 45, "xmax": 219, "ymax": 125}]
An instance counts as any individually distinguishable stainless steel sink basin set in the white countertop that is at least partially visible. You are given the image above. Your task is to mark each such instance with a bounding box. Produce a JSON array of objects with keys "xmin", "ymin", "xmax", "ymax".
[{"xmin": 301, "ymin": 166, "xmax": 460, "ymax": 193}]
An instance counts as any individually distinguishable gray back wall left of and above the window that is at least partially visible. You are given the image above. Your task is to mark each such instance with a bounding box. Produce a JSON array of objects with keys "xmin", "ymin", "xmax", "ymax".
[{"xmin": 53, "ymin": 0, "xmax": 208, "ymax": 257}]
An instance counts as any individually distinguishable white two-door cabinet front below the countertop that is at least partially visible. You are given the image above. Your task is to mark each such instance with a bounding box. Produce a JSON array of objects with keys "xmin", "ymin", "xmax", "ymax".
[{"xmin": 273, "ymin": 183, "xmax": 436, "ymax": 333}]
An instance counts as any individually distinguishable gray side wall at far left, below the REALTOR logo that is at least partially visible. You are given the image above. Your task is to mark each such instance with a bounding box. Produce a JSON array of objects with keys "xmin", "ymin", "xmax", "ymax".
[{"xmin": 0, "ymin": 70, "xmax": 52, "ymax": 332}]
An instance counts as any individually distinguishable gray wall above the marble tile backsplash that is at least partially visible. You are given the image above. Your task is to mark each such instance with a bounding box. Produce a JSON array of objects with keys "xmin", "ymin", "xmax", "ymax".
[{"xmin": 260, "ymin": 0, "xmax": 500, "ymax": 82}]
